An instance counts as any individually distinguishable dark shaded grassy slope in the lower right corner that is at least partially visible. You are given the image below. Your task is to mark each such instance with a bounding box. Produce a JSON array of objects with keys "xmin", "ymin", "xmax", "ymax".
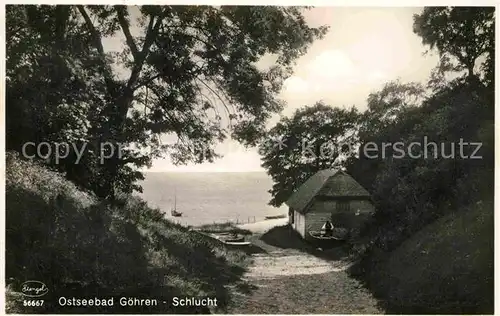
[{"xmin": 358, "ymin": 202, "xmax": 494, "ymax": 314}]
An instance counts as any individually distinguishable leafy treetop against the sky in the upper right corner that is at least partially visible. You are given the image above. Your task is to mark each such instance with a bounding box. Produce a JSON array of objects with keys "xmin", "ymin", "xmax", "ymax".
[{"xmin": 413, "ymin": 7, "xmax": 495, "ymax": 83}]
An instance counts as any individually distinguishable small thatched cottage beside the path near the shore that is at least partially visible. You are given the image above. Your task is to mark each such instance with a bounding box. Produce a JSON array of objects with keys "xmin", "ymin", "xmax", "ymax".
[{"xmin": 286, "ymin": 169, "xmax": 375, "ymax": 239}]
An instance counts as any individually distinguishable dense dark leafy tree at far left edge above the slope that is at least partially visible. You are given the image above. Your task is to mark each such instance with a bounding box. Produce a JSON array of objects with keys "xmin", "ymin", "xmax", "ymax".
[{"xmin": 6, "ymin": 6, "xmax": 109, "ymax": 189}]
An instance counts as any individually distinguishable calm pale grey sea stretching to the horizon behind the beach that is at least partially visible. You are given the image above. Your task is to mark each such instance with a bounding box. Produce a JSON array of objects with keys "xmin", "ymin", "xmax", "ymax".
[{"xmin": 140, "ymin": 172, "xmax": 287, "ymax": 226}]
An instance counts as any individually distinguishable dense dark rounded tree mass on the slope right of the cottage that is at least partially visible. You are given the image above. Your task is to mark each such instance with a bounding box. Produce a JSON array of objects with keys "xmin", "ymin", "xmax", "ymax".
[{"xmin": 347, "ymin": 75, "xmax": 494, "ymax": 250}]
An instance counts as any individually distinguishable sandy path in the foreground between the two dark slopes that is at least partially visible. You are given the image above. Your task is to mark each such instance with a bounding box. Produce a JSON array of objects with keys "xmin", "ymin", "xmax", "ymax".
[{"xmin": 228, "ymin": 222, "xmax": 382, "ymax": 314}]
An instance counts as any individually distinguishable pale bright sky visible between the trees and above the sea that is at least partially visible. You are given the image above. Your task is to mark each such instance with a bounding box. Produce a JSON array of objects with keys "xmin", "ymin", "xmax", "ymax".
[{"xmin": 108, "ymin": 7, "xmax": 438, "ymax": 172}]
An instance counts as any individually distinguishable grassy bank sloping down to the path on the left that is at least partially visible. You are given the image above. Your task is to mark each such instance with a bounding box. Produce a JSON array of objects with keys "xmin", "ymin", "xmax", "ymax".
[{"xmin": 6, "ymin": 153, "xmax": 248, "ymax": 313}]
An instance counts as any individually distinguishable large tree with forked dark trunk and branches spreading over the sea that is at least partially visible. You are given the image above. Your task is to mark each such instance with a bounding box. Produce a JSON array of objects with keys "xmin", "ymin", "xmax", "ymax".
[{"xmin": 7, "ymin": 5, "xmax": 327, "ymax": 197}]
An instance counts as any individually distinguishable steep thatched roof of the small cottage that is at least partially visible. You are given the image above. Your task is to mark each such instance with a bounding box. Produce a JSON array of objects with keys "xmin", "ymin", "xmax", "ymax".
[{"xmin": 286, "ymin": 169, "xmax": 370, "ymax": 213}]
